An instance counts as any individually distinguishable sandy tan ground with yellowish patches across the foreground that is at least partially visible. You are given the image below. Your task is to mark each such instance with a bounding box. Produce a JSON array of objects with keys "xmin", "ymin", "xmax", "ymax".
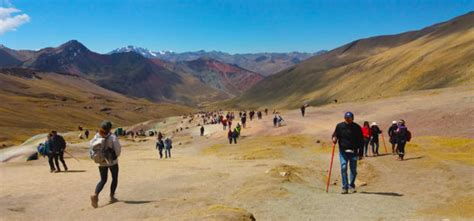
[{"xmin": 0, "ymin": 88, "xmax": 474, "ymax": 220}]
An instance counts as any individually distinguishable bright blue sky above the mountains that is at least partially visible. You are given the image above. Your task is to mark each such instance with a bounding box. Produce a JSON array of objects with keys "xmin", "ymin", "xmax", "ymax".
[{"xmin": 0, "ymin": 0, "xmax": 474, "ymax": 53}]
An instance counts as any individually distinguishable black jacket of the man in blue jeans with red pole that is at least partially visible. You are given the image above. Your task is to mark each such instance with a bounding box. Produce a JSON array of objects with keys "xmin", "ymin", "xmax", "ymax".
[{"xmin": 332, "ymin": 122, "xmax": 364, "ymax": 156}]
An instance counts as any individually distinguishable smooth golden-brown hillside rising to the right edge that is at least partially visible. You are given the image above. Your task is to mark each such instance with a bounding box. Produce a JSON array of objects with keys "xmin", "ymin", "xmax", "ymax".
[{"xmin": 227, "ymin": 12, "xmax": 474, "ymax": 108}]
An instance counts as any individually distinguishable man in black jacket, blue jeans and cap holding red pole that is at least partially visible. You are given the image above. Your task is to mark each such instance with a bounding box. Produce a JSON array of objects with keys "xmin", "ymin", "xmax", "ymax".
[{"xmin": 332, "ymin": 112, "xmax": 364, "ymax": 194}]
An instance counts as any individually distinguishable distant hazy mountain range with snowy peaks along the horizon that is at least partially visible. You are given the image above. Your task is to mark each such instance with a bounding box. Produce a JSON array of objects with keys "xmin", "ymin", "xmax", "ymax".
[{"xmin": 108, "ymin": 46, "xmax": 327, "ymax": 76}]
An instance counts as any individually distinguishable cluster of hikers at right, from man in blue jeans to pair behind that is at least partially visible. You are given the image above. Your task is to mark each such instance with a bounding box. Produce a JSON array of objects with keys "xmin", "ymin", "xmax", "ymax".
[{"xmin": 332, "ymin": 112, "xmax": 411, "ymax": 194}]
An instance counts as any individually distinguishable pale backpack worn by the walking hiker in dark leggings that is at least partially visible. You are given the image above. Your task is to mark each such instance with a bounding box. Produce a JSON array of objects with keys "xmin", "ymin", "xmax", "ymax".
[{"xmin": 89, "ymin": 135, "xmax": 117, "ymax": 164}]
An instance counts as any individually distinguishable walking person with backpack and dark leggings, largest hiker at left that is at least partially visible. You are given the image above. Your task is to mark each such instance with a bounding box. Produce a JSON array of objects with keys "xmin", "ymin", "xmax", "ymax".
[{"xmin": 90, "ymin": 121, "xmax": 122, "ymax": 208}]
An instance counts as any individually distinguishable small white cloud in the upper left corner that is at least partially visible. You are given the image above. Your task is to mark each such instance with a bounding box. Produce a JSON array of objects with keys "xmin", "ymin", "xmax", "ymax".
[{"xmin": 0, "ymin": 7, "xmax": 30, "ymax": 35}]
